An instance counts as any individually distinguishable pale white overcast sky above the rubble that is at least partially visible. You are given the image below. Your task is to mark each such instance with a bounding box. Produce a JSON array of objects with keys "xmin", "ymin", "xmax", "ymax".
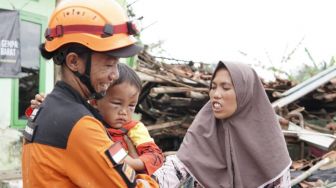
[{"xmin": 128, "ymin": 0, "xmax": 336, "ymax": 79}]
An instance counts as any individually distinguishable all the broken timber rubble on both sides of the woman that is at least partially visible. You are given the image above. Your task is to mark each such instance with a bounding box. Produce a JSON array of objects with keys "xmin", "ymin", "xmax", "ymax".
[{"xmin": 136, "ymin": 51, "xmax": 336, "ymax": 187}]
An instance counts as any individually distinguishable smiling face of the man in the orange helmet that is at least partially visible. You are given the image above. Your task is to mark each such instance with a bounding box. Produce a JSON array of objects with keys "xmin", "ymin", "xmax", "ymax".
[{"xmin": 90, "ymin": 53, "xmax": 119, "ymax": 93}]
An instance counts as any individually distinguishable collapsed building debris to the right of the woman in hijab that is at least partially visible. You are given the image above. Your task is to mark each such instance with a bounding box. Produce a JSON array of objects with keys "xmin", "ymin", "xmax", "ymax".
[{"xmin": 258, "ymin": 74, "xmax": 336, "ymax": 188}]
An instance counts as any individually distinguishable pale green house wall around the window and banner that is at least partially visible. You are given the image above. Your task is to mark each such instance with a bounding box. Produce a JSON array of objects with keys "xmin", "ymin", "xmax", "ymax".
[{"xmin": 0, "ymin": 0, "xmax": 56, "ymax": 170}]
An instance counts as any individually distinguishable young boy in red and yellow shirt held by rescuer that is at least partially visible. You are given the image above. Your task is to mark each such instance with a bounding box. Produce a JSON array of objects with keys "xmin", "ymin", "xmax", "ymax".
[{"xmin": 26, "ymin": 63, "xmax": 164, "ymax": 175}]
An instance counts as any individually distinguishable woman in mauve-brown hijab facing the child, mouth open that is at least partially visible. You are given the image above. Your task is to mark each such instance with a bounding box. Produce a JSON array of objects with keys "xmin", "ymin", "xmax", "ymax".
[{"xmin": 154, "ymin": 62, "xmax": 291, "ymax": 188}]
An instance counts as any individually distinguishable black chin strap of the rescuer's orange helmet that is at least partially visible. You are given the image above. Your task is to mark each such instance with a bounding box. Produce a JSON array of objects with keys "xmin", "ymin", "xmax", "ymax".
[{"xmin": 73, "ymin": 52, "xmax": 104, "ymax": 100}]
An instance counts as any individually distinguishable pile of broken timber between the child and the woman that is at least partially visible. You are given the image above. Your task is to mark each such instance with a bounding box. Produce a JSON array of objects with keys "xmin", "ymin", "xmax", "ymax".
[{"xmin": 136, "ymin": 51, "xmax": 212, "ymax": 150}]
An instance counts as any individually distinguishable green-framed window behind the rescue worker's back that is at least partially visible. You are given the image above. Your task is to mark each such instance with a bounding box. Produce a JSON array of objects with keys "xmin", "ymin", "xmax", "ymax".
[{"xmin": 12, "ymin": 11, "xmax": 47, "ymax": 128}]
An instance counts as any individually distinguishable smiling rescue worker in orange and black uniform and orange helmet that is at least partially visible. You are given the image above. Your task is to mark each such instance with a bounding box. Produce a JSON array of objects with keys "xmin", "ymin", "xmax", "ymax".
[{"xmin": 22, "ymin": 0, "xmax": 158, "ymax": 188}]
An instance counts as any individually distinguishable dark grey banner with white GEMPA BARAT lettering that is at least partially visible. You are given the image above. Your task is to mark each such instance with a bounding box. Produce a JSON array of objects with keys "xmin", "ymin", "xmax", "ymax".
[{"xmin": 0, "ymin": 9, "xmax": 21, "ymax": 78}]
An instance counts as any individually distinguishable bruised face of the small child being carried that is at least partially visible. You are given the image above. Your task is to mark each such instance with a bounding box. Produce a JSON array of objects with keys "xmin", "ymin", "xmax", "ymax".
[{"xmin": 97, "ymin": 82, "xmax": 140, "ymax": 129}]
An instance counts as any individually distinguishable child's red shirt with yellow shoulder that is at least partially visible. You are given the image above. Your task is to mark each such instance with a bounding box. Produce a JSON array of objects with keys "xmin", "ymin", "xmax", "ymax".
[{"xmin": 107, "ymin": 121, "xmax": 164, "ymax": 175}]
